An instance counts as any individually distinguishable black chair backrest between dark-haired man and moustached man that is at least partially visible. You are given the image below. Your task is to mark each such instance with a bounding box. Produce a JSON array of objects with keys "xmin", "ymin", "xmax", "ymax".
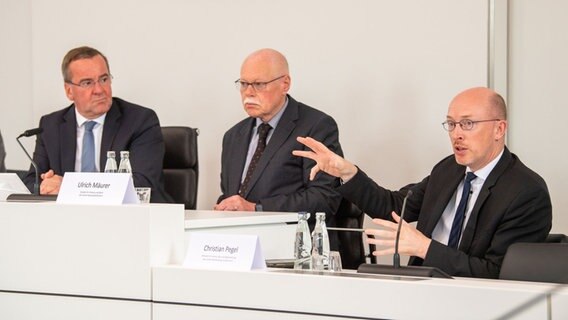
[{"xmin": 162, "ymin": 127, "xmax": 199, "ymax": 209}]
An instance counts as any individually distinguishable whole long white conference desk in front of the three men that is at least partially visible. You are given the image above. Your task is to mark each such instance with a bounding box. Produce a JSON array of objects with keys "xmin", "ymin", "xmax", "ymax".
[{"xmin": 0, "ymin": 202, "xmax": 568, "ymax": 320}]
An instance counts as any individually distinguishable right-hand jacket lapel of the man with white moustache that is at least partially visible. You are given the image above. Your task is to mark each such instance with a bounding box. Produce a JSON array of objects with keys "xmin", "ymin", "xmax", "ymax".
[{"xmin": 245, "ymin": 96, "xmax": 298, "ymax": 198}]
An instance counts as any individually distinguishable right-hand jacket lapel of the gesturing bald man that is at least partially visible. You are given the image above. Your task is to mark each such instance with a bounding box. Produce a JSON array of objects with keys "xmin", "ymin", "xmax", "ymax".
[{"xmin": 459, "ymin": 147, "xmax": 512, "ymax": 252}]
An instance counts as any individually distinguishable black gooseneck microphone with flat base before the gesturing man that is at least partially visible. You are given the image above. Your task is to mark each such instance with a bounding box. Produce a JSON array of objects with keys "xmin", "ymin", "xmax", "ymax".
[{"xmin": 357, "ymin": 190, "xmax": 452, "ymax": 279}]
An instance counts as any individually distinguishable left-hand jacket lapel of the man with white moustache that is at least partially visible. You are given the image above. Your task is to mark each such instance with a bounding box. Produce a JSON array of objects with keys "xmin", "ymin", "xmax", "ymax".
[{"xmin": 227, "ymin": 118, "xmax": 256, "ymax": 194}]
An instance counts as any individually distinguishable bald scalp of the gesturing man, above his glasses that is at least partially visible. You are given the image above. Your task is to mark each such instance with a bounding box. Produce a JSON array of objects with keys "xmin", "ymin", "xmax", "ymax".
[{"xmin": 450, "ymin": 87, "xmax": 507, "ymax": 120}]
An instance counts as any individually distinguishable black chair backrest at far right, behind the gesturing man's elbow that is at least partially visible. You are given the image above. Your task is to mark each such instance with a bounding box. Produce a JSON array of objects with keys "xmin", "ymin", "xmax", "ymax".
[{"xmin": 499, "ymin": 243, "xmax": 568, "ymax": 283}]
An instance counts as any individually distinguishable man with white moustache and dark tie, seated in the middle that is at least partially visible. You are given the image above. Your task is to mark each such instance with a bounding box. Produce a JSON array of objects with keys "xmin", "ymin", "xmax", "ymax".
[{"xmin": 215, "ymin": 49, "xmax": 342, "ymax": 216}]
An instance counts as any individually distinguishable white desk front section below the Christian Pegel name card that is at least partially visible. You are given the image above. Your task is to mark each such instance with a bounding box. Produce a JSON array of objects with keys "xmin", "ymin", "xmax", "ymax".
[{"xmin": 152, "ymin": 266, "xmax": 568, "ymax": 320}]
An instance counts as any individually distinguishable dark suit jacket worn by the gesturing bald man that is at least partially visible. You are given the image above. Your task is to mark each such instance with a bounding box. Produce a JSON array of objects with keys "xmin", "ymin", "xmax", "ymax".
[{"xmin": 339, "ymin": 148, "xmax": 552, "ymax": 278}]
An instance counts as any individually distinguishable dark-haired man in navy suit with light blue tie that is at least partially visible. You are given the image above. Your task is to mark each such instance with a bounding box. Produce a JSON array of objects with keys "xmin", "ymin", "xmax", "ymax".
[{"xmin": 24, "ymin": 47, "xmax": 172, "ymax": 202}]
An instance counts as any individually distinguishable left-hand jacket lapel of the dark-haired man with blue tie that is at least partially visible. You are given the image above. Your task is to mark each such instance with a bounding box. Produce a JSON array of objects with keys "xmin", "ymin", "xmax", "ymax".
[{"xmin": 59, "ymin": 105, "xmax": 77, "ymax": 174}]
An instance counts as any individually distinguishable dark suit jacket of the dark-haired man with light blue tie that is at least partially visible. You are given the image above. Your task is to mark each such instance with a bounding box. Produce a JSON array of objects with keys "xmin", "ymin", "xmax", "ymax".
[{"xmin": 24, "ymin": 98, "xmax": 173, "ymax": 202}]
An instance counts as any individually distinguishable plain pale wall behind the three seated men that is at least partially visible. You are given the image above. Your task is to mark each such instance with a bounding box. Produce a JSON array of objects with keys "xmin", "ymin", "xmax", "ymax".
[{"xmin": 0, "ymin": 0, "xmax": 568, "ymax": 232}]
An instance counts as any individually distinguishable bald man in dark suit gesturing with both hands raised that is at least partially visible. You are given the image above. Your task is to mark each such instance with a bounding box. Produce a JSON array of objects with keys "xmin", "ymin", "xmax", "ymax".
[{"xmin": 294, "ymin": 88, "xmax": 552, "ymax": 278}]
